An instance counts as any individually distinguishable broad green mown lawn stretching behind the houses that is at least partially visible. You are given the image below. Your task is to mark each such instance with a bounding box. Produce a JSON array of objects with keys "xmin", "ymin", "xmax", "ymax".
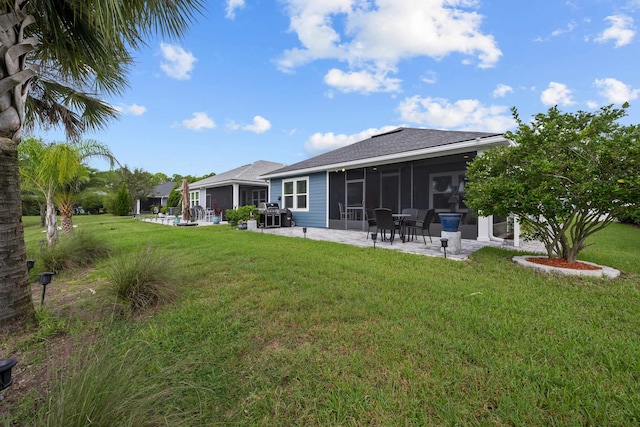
[{"xmin": 5, "ymin": 216, "xmax": 640, "ymax": 426}]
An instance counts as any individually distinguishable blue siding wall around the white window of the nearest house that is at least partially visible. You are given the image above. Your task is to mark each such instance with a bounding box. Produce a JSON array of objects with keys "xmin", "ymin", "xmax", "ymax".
[{"xmin": 269, "ymin": 172, "xmax": 327, "ymax": 228}]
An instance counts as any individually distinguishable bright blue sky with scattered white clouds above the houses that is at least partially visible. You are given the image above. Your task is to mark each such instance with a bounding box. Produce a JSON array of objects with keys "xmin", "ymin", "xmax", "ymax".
[{"xmin": 36, "ymin": 0, "xmax": 640, "ymax": 176}]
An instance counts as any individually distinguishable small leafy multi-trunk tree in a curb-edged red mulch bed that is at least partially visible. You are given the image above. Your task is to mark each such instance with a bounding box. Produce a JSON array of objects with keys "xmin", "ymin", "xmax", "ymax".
[{"xmin": 465, "ymin": 104, "xmax": 640, "ymax": 262}]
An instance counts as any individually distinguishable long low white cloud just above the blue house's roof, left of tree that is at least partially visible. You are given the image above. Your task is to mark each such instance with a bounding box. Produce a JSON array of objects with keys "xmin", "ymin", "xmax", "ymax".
[{"xmin": 398, "ymin": 96, "xmax": 515, "ymax": 132}]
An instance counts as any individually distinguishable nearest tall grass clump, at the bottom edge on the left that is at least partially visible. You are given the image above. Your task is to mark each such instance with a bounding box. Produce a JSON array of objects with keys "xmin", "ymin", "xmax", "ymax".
[{"xmin": 33, "ymin": 340, "xmax": 190, "ymax": 427}]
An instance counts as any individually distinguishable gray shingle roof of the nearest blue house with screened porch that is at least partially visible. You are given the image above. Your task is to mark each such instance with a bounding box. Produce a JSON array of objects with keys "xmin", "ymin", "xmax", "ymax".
[{"xmin": 267, "ymin": 127, "xmax": 502, "ymax": 176}]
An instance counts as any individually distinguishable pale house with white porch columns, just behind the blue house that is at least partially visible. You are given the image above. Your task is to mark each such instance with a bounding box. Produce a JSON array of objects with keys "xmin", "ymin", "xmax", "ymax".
[{"xmin": 189, "ymin": 160, "xmax": 285, "ymax": 214}]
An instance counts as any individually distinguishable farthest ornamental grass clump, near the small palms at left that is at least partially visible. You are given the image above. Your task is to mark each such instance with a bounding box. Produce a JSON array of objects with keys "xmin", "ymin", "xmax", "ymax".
[{"xmin": 40, "ymin": 230, "xmax": 111, "ymax": 273}]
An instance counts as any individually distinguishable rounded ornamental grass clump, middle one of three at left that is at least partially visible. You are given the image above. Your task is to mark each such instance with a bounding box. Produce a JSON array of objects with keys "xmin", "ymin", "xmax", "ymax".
[{"xmin": 106, "ymin": 246, "xmax": 180, "ymax": 311}]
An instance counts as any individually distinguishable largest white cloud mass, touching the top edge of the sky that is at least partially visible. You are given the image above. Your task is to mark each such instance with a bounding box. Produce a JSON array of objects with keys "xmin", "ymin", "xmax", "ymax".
[{"xmin": 277, "ymin": 0, "xmax": 502, "ymax": 91}]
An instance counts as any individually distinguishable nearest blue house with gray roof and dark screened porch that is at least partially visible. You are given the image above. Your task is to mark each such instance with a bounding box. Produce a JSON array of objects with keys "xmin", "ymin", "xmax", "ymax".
[{"xmin": 262, "ymin": 128, "xmax": 511, "ymax": 241}]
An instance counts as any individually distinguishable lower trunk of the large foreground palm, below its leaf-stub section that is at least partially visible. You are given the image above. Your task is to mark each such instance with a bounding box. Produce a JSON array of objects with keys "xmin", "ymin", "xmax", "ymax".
[{"xmin": 0, "ymin": 138, "xmax": 35, "ymax": 324}]
